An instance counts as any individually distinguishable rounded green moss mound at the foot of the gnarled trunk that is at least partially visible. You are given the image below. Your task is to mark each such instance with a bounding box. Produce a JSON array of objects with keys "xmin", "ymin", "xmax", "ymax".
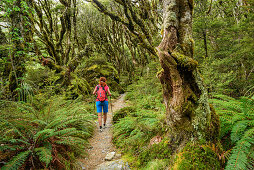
[{"xmin": 171, "ymin": 144, "xmax": 221, "ymax": 170}]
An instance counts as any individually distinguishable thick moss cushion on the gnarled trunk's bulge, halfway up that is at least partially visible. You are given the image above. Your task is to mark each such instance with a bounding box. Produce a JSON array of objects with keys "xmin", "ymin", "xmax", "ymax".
[{"xmin": 172, "ymin": 51, "xmax": 198, "ymax": 71}]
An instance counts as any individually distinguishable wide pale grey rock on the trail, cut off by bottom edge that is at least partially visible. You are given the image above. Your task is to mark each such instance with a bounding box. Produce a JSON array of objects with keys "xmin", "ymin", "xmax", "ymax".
[{"xmin": 96, "ymin": 160, "xmax": 131, "ymax": 170}]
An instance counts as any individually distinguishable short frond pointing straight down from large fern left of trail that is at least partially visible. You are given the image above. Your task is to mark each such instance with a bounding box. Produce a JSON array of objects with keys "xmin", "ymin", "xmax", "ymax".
[{"xmin": 34, "ymin": 147, "xmax": 52, "ymax": 167}]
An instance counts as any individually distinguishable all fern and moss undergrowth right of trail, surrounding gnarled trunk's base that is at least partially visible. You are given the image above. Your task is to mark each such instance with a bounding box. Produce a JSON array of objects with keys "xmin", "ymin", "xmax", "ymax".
[{"xmin": 113, "ymin": 62, "xmax": 254, "ymax": 169}]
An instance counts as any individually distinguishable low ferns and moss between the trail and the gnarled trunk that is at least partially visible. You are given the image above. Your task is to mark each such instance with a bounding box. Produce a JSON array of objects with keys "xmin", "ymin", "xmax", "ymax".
[{"xmin": 113, "ymin": 61, "xmax": 171, "ymax": 169}]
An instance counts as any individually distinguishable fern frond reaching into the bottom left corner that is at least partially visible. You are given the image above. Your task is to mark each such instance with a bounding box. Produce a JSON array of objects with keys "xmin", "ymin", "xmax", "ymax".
[{"xmin": 2, "ymin": 150, "xmax": 31, "ymax": 170}]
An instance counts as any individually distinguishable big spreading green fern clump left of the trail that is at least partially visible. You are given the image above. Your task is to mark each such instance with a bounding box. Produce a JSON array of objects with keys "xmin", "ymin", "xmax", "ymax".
[{"xmin": 0, "ymin": 96, "xmax": 94, "ymax": 169}]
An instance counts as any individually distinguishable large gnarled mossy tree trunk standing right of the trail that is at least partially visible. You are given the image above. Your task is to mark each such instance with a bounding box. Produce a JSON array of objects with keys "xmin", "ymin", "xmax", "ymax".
[{"xmin": 157, "ymin": 0, "xmax": 217, "ymax": 149}]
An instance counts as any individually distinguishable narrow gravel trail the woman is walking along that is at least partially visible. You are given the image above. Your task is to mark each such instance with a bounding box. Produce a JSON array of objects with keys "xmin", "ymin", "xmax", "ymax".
[{"xmin": 81, "ymin": 94, "xmax": 125, "ymax": 170}]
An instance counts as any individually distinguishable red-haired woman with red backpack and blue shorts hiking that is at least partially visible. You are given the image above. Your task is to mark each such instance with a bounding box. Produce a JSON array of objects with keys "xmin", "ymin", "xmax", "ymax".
[{"xmin": 93, "ymin": 77, "xmax": 111, "ymax": 132}]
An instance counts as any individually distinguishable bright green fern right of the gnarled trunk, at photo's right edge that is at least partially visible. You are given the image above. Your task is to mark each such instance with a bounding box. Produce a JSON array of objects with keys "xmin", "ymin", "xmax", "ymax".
[{"xmin": 211, "ymin": 95, "xmax": 254, "ymax": 169}]
